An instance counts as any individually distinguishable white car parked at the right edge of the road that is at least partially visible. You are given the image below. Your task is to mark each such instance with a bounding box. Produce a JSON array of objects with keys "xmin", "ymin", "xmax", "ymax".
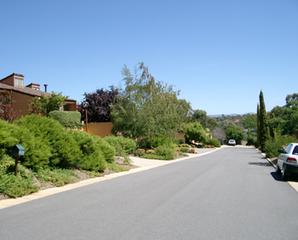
[{"xmin": 277, "ymin": 143, "xmax": 298, "ymax": 180}]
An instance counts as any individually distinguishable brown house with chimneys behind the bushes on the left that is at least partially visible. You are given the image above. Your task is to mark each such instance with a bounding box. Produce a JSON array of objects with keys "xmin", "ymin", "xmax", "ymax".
[{"xmin": 0, "ymin": 73, "xmax": 77, "ymax": 120}]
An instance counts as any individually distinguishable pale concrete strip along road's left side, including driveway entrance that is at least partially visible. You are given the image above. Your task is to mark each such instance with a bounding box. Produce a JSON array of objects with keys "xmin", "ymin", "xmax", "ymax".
[{"xmin": 0, "ymin": 148, "xmax": 220, "ymax": 209}]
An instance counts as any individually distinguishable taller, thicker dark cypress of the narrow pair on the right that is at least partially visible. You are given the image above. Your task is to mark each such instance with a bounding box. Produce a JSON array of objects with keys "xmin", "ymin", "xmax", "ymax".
[{"xmin": 259, "ymin": 91, "xmax": 268, "ymax": 151}]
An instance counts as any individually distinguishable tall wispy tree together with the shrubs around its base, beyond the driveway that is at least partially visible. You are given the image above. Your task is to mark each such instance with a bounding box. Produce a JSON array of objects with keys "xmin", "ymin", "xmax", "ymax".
[{"xmin": 111, "ymin": 63, "xmax": 219, "ymax": 160}]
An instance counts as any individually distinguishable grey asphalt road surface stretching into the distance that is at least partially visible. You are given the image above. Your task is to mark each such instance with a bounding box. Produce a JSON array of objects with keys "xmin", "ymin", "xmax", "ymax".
[{"xmin": 0, "ymin": 147, "xmax": 298, "ymax": 240}]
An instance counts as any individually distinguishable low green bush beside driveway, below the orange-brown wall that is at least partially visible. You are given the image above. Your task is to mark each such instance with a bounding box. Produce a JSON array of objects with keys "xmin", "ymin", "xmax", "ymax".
[{"xmin": 104, "ymin": 136, "xmax": 136, "ymax": 156}]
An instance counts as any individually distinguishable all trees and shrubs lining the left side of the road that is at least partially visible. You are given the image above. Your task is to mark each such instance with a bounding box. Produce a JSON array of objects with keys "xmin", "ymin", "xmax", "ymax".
[{"xmin": 0, "ymin": 63, "xmax": 220, "ymax": 198}]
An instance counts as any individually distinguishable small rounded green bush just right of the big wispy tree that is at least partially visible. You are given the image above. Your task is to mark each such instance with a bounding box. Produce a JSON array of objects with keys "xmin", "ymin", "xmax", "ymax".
[{"xmin": 184, "ymin": 122, "xmax": 207, "ymax": 143}]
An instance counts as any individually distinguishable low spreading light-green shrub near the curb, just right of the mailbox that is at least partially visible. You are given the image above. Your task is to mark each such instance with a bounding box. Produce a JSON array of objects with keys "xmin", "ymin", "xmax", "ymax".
[{"xmin": 36, "ymin": 168, "xmax": 78, "ymax": 187}]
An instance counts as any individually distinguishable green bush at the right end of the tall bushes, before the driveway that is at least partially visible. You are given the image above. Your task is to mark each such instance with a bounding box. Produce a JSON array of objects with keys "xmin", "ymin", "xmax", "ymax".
[{"xmin": 72, "ymin": 131, "xmax": 106, "ymax": 172}]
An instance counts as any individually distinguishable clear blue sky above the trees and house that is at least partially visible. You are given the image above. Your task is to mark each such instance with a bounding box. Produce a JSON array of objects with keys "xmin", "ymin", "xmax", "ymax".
[{"xmin": 0, "ymin": 0, "xmax": 298, "ymax": 114}]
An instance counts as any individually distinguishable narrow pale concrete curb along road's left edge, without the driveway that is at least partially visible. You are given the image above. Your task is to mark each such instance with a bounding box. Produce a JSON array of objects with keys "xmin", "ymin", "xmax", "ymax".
[{"xmin": 0, "ymin": 148, "xmax": 221, "ymax": 210}]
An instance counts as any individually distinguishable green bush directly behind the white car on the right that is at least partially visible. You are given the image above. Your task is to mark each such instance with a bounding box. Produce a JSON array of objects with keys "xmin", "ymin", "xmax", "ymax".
[{"xmin": 264, "ymin": 136, "xmax": 297, "ymax": 158}]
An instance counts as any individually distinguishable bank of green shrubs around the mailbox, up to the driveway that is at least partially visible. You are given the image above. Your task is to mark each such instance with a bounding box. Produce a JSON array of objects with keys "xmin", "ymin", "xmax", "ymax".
[{"xmin": 0, "ymin": 115, "xmax": 135, "ymax": 197}]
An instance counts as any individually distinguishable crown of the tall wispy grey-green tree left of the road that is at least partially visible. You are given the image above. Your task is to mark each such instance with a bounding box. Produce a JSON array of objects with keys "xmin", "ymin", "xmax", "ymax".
[{"xmin": 112, "ymin": 63, "xmax": 190, "ymax": 142}]
